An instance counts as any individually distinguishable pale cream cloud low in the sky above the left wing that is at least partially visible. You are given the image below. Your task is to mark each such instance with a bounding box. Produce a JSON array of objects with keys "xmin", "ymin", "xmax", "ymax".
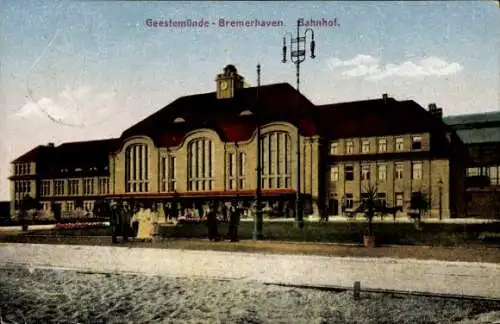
[{"xmin": 13, "ymin": 85, "xmax": 115, "ymax": 127}]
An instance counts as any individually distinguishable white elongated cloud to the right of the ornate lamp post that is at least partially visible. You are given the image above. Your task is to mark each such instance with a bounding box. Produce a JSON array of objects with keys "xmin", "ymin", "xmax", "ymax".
[{"xmin": 328, "ymin": 54, "xmax": 463, "ymax": 81}]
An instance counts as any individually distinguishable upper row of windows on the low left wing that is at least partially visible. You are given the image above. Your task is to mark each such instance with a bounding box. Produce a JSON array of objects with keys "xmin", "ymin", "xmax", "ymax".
[{"xmin": 40, "ymin": 178, "xmax": 109, "ymax": 196}]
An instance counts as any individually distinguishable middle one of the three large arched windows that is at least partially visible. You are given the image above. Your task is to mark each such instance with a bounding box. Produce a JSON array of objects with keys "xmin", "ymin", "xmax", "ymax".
[{"xmin": 187, "ymin": 138, "xmax": 214, "ymax": 191}]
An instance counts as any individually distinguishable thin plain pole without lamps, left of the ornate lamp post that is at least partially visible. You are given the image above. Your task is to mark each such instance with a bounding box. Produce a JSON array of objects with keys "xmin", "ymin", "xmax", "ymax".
[{"xmin": 253, "ymin": 64, "xmax": 264, "ymax": 240}]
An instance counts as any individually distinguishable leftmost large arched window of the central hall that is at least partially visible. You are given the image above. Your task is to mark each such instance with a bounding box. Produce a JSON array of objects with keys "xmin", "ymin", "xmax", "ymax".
[{"xmin": 125, "ymin": 144, "xmax": 149, "ymax": 192}]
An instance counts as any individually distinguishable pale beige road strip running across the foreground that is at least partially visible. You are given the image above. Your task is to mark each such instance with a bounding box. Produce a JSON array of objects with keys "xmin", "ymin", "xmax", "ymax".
[{"xmin": 0, "ymin": 243, "xmax": 500, "ymax": 300}]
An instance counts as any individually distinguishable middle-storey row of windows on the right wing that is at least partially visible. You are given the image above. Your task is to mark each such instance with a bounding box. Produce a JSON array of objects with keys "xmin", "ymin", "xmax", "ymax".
[{"xmin": 330, "ymin": 161, "xmax": 423, "ymax": 181}]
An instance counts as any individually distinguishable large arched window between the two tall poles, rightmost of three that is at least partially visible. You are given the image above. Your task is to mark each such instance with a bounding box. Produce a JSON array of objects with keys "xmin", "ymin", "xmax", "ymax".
[{"xmin": 261, "ymin": 132, "xmax": 291, "ymax": 189}]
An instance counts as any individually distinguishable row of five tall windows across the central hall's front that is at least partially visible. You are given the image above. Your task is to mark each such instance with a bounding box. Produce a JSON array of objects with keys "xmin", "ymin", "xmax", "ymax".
[{"xmin": 125, "ymin": 132, "xmax": 291, "ymax": 192}]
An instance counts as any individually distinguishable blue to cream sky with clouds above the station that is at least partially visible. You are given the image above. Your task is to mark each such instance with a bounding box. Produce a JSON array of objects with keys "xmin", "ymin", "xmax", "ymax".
[{"xmin": 0, "ymin": 0, "xmax": 500, "ymax": 200}]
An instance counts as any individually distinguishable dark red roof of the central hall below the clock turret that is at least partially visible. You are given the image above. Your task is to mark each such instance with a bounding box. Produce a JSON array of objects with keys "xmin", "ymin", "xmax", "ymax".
[{"xmin": 121, "ymin": 83, "xmax": 315, "ymax": 145}]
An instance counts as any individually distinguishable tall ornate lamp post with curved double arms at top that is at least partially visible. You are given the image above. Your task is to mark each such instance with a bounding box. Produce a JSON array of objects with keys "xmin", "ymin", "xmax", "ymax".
[{"xmin": 282, "ymin": 19, "xmax": 316, "ymax": 228}]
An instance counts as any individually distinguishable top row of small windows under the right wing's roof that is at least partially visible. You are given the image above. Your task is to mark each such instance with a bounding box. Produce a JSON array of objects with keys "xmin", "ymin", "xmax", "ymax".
[{"xmin": 330, "ymin": 136, "xmax": 422, "ymax": 155}]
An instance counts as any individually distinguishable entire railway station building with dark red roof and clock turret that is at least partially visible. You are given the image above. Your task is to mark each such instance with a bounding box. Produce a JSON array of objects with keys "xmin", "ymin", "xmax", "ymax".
[{"xmin": 10, "ymin": 65, "xmax": 464, "ymax": 218}]
